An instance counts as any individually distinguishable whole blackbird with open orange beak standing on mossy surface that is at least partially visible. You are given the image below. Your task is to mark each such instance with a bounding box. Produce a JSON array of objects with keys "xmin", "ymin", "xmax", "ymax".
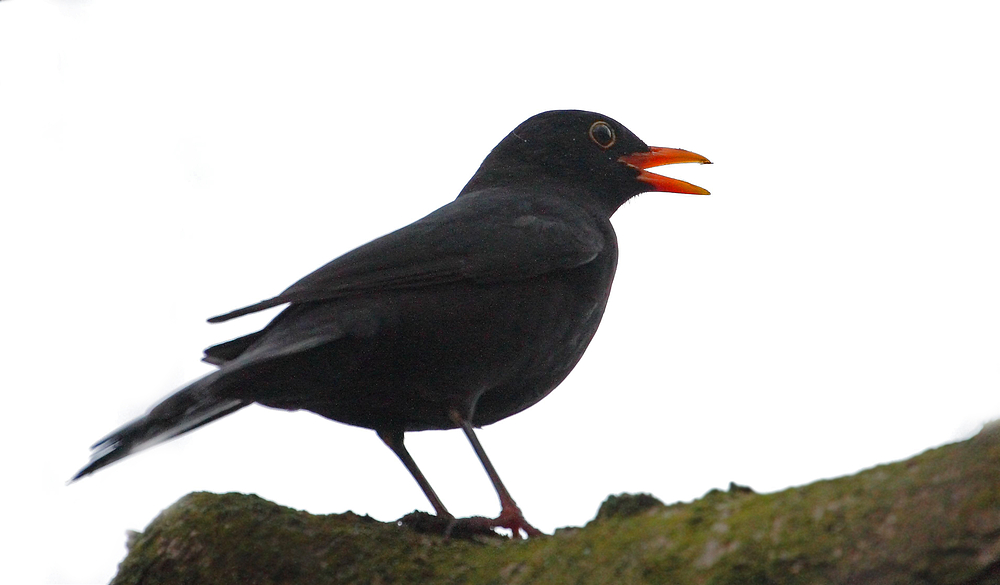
[{"xmin": 71, "ymin": 110, "xmax": 709, "ymax": 538}]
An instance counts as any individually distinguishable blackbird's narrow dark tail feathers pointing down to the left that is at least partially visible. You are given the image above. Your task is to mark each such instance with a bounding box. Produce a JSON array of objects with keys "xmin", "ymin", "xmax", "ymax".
[{"xmin": 70, "ymin": 373, "xmax": 250, "ymax": 482}]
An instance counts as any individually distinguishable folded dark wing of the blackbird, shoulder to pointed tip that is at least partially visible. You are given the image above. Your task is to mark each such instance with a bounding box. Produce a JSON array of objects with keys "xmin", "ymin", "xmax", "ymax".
[{"xmin": 209, "ymin": 189, "xmax": 608, "ymax": 323}]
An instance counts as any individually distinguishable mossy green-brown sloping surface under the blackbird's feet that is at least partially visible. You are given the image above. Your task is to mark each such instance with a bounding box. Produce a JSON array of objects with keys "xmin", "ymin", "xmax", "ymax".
[{"xmin": 112, "ymin": 423, "xmax": 1000, "ymax": 585}]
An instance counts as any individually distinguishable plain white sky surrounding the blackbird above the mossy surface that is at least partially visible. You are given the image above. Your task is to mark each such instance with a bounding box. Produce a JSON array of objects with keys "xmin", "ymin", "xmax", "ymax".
[{"xmin": 0, "ymin": 0, "xmax": 1000, "ymax": 583}]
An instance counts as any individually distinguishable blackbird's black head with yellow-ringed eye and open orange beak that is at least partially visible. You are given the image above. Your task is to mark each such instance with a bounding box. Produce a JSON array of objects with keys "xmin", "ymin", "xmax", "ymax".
[{"xmin": 462, "ymin": 110, "xmax": 710, "ymax": 212}]
